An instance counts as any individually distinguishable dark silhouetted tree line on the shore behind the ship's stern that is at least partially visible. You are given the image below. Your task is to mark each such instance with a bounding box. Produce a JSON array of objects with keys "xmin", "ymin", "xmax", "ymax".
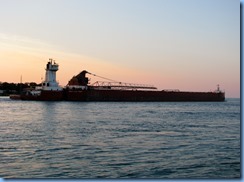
[{"xmin": 0, "ymin": 82, "xmax": 41, "ymax": 96}]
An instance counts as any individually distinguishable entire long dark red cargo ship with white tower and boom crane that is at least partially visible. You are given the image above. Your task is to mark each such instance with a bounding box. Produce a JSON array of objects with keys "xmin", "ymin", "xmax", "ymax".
[{"xmin": 10, "ymin": 59, "xmax": 225, "ymax": 102}]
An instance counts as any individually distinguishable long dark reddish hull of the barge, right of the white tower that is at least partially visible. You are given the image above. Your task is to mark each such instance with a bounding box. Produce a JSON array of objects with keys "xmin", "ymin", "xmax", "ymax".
[{"xmin": 64, "ymin": 90, "xmax": 225, "ymax": 102}]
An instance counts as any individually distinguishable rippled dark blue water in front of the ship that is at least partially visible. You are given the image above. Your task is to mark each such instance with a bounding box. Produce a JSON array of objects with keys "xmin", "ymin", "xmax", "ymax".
[{"xmin": 0, "ymin": 97, "xmax": 240, "ymax": 179}]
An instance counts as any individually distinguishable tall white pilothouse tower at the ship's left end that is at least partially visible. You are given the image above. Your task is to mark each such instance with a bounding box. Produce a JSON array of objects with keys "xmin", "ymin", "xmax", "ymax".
[{"xmin": 42, "ymin": 59, "xmax": 63, "ymax": 90}]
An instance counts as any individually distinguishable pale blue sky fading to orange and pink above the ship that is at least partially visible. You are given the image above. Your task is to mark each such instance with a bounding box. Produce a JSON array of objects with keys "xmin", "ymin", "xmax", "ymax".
[{"xmin": 0, "ymin": 0, "xmax": 240, "ymax": 98}]
